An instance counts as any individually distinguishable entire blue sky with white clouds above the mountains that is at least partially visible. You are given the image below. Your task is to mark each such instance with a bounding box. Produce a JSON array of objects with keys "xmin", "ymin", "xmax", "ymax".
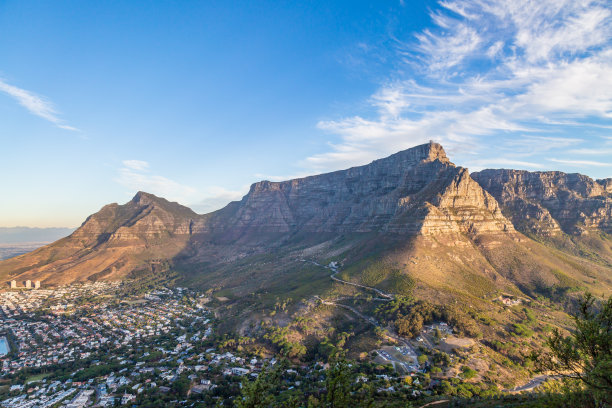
[{"xmin": 0, "ymin": 0, "xmax": 612, "ymax": 227}]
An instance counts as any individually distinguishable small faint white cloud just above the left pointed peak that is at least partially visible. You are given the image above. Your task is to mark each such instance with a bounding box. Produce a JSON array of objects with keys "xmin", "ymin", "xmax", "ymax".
[{"xmin": 116, "ymin": 160, "xmax": 198, "ymax": 204}]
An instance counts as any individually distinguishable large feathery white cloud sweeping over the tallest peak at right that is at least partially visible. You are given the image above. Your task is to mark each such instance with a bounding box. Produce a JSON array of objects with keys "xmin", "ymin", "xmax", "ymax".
[{"xmin": 304, "ymin": 0, "xmax": 612, "ymax": 174}]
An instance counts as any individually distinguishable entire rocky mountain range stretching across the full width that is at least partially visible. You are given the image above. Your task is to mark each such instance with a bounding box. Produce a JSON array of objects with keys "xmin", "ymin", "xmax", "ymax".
[{"xmin": 0, "ymin": 142, "xmax": 612, "ymax": 306}]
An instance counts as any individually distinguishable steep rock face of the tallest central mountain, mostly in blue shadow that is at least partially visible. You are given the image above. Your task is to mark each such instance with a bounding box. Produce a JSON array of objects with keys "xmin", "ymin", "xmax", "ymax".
[{"xmin": 210, "ymin": 143, "xmax": 513, "ymax": 238}]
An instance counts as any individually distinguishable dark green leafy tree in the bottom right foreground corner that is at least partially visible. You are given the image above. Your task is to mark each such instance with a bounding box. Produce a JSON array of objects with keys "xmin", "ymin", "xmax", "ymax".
[{"xmin": 532, "ymin": 293, "xmax": 612, "ymax": 406}]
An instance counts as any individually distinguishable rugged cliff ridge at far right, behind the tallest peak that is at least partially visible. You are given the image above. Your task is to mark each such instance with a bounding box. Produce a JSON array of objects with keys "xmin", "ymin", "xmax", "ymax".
[{"xmin": 472, "ymin": 169, "xmax": 612, "ymax": 235}]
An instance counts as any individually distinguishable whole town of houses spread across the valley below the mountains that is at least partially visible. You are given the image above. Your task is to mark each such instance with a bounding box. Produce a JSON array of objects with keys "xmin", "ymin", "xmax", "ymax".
[{"xmin": 0, "ymin": 282, "xmax": 500, "ymax": 408}]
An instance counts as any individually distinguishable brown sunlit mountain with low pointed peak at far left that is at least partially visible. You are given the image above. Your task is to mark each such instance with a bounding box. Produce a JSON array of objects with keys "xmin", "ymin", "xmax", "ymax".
[{"xmin": 0, "ymin": 192, "xmax": 200, "ymax": 284}]
